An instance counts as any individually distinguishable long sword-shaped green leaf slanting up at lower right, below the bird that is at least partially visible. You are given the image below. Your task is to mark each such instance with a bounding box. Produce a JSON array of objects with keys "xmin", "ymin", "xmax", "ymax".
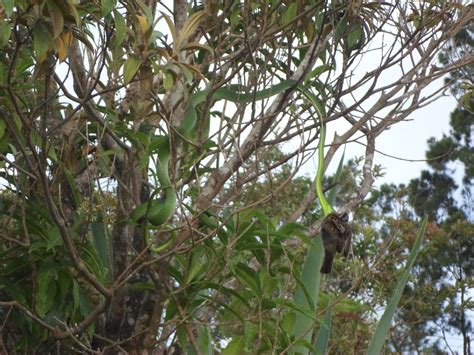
[{"xmin": 367, "ymin": 216, "xmax": 428, "ymax": 355}]
